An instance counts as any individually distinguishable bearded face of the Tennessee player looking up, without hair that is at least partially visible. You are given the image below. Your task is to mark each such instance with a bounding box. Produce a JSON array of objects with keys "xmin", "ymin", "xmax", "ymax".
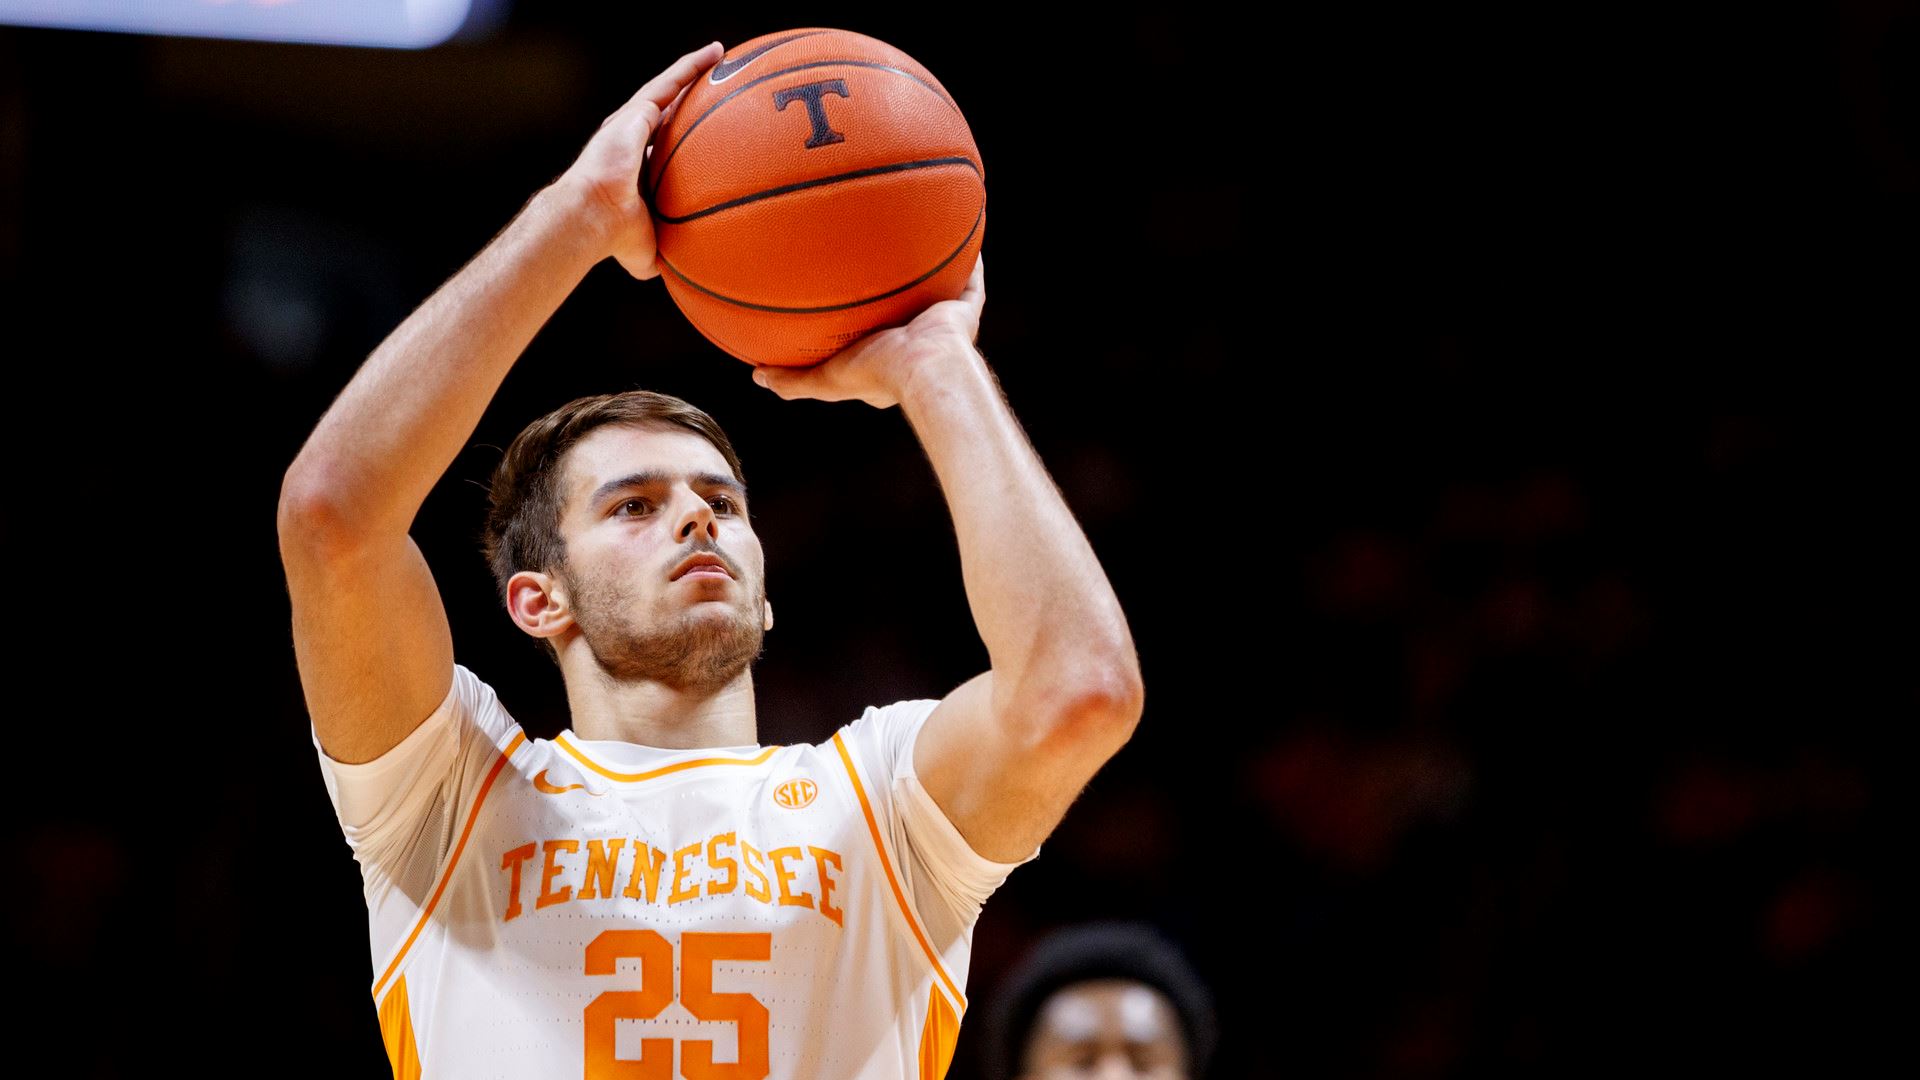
[{"xmin": 557, "ymin": 425, "xmax": 770, "ymax": 692}]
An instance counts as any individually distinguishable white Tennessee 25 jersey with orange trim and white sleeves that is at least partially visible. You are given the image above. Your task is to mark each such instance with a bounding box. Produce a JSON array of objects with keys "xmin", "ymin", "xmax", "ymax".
[{"xmin": 313, "ymin": 665, "xmax": 1039, "ymax": 1080}]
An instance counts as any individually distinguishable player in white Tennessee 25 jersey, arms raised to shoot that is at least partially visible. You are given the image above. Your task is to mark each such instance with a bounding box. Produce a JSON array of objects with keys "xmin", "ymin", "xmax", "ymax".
[{"xmin": 278, "ymin": 42, "xmax": 1142, "ymax": 1080}]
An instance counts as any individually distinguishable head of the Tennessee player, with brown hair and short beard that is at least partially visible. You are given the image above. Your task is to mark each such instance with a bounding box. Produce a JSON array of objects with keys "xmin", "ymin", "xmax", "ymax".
[{"xmin": 482, "ymin": 390, "xmax": 774, "ymax": 694}]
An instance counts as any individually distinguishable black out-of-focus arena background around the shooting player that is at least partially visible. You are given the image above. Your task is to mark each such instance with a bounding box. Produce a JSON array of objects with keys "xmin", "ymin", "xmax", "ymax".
[{"xmin": 0, "ymin": 0, "xmax": 1920, "ymax": 1080}]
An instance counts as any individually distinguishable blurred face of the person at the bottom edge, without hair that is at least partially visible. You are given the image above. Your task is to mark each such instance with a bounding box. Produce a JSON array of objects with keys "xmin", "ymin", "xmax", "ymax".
[{"xmin": 1021, "ymin": 978, "xmax": 1187, "ymax": 1080}]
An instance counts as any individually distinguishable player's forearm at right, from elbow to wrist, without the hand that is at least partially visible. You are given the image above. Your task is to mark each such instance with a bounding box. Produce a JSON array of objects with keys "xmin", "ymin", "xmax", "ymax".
[{"xmin": 900, "ymin": 350, "xmax": 1140, "ymax": 717}]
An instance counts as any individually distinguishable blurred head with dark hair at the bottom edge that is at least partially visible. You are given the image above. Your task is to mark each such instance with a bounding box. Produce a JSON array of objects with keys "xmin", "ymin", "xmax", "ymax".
[{"xmin": 987, "ymin": 922, "xmax": 1217, "ymax": 1080}]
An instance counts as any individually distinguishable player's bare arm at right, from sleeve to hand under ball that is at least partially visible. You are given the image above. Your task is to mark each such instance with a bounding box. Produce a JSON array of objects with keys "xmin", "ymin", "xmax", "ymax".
[{"xmin": 755, "ymin": 249, "xmax": 1144, "ymax": 863}]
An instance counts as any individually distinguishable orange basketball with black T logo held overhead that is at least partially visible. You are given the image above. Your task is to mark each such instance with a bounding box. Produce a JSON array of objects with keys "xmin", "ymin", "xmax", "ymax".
[{"xmin": 639, "ymin": 29, "xmax": 987, "ymax": 367}]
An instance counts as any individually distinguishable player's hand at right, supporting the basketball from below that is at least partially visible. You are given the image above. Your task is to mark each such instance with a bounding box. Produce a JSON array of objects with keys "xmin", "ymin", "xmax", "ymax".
[{"xmin": 753, "ymin": 256, "xmax": 987, "ymax": 409}]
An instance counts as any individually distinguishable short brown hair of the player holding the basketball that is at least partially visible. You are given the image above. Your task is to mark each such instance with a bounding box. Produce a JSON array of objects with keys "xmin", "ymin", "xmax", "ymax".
[{"xmin": 480, "ymin": 390, "xmax": 747, "ymax": 665}]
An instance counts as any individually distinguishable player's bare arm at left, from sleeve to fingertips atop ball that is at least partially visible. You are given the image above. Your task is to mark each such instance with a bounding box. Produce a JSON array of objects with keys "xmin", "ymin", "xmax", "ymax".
[{"xmin": 278, "ymin": 42, "xmax": 722, "ymax": 763}]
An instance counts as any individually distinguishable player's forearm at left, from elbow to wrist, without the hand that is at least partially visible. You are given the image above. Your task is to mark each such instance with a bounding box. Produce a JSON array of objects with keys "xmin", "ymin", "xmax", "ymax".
[{"xmin": 282, "ymin": 183, "xmax": 605, "ymax": 536}]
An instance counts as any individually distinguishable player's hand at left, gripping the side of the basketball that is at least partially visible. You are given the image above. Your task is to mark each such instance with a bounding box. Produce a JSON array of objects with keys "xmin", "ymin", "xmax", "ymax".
[{"xmin": 555, "ymin": 42, "xmax": 726, "ymax": 281}]
